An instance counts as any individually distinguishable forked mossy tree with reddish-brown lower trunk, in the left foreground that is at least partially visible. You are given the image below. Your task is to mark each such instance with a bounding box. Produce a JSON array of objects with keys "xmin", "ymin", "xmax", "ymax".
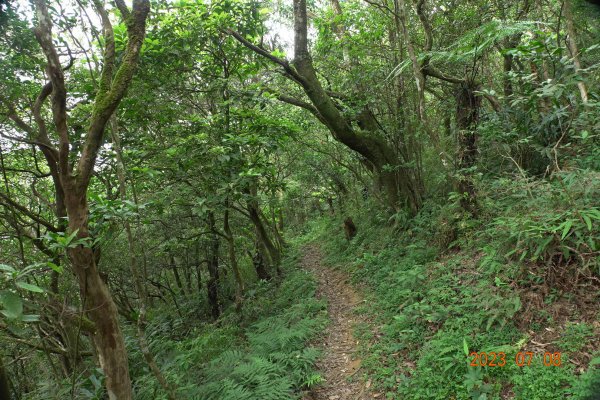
[{"xmin": 33, "ymin": 0, "xmax": 150, "ymax": 400}]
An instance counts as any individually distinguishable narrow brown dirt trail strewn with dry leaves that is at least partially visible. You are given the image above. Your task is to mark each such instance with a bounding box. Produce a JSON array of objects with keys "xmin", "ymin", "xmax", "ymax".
[{"xmin": 302, "ymin": 245, "xmax": 374, "ymax": 400}]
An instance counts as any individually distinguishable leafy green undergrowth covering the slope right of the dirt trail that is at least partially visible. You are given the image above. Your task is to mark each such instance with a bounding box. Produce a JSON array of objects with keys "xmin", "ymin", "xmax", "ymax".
[{"xmin": 304, "ymin": 172, "xmax": 600, "ymax": 400}]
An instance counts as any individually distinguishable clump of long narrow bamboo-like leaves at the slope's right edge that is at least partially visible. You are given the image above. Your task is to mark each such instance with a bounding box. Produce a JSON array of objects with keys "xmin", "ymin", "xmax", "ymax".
[{"xmin": 490, "ymin": 171, "xmax": 600, "ymax": 270}]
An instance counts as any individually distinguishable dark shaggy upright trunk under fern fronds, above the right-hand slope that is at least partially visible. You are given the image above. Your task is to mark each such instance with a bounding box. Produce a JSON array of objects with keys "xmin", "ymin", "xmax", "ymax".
[{"xmin": 456, "ymin": 83, "xmax": 481, "ymax": 216}]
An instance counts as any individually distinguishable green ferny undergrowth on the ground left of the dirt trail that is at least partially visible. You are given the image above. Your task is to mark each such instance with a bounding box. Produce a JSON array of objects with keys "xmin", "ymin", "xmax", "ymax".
[{"xmin": 35, "ymin": 250, "xmax": 327, "ymax": 400}]
